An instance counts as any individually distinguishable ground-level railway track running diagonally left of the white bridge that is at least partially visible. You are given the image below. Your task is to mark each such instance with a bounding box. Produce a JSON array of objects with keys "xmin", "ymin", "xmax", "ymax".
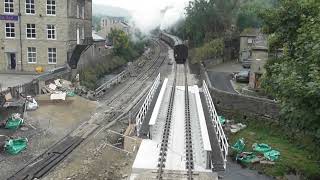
[{"xmin": 9, "ymin": 38, "xmax": 166, "ymax": 180}]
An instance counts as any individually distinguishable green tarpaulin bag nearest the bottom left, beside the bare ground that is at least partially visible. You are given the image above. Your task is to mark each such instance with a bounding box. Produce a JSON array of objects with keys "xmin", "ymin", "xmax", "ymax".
[{"xmin": 4, "ymin": 138, "xmax": 28, "ymax": 155}]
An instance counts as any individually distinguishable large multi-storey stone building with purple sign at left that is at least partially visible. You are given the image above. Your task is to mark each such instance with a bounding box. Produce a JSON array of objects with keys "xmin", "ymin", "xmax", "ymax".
[{"xmin": 0, "ymin": 0, "xmax": 92, "ymax": 72}]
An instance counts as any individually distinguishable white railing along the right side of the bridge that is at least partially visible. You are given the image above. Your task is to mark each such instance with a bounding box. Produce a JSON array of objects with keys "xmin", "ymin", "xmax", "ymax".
[{"xmin": 203, "ymin": 81, "xmax": 229, "ymax": 169}]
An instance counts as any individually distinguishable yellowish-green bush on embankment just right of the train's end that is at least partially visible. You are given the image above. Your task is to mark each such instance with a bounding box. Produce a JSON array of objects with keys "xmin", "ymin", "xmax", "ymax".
[{"xmin": 191, "ymin": 38, "xmax": 224, "ymax": 63}]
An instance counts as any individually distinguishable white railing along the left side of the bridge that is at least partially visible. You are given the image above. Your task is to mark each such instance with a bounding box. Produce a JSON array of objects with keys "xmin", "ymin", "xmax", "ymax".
[{"xmin": 136, "ymin": 73, "xmax": 160, "ymax": 136}]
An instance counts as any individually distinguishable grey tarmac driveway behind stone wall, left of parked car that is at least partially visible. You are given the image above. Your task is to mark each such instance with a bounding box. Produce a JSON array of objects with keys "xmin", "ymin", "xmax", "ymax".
[{"xmin": 208, "ymin": 71, "xmax": 237, "ymax": 94}]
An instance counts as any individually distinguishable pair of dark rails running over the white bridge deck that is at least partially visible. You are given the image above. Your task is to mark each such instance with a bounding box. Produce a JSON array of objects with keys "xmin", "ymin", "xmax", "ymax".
[{"xmin": 157, "ymin": 64, "xmax": 194, "ymax": 180}]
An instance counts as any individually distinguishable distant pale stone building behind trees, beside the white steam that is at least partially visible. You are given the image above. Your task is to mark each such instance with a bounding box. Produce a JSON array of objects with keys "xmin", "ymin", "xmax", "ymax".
[{"xmin": 99, "ymin": 17, "xmax": 130, "ymax": 37}]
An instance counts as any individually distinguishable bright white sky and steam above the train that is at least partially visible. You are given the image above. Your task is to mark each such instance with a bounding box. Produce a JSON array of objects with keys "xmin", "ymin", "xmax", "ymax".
[{"xmin": 93, "ymin": 0, "xmax": 189, "ymax": 32}]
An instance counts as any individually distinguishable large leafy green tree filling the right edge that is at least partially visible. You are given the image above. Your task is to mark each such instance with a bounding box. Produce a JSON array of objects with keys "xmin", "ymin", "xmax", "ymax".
[{"xmin": 262, "ymin": 0, "xmax": 320, "ymax": 143}]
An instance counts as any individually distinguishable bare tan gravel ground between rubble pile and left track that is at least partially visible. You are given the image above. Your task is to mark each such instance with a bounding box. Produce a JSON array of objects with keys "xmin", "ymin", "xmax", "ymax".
[{"xmin": 0, "ymin": 96, "xmax": 97, "ymax": 179}]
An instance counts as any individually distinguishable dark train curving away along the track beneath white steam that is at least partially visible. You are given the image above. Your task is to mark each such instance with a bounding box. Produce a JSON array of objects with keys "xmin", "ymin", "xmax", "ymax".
[{"xmin": 160, "ymin": 32, "xmax": 188, "ymax": 64}]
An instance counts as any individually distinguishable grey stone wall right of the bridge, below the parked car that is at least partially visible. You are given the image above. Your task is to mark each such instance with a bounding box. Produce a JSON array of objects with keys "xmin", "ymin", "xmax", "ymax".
[{"xmin": 200, "ymin": 65, "xmax": 279, "ymax": 120}]
